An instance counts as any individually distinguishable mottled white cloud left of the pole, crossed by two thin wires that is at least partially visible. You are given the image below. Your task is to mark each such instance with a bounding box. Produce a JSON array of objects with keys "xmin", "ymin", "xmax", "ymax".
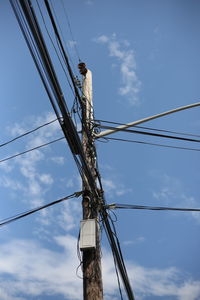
[{"xmin": 0, "ymin": 113, "xmax": 61, "ymax": 216}]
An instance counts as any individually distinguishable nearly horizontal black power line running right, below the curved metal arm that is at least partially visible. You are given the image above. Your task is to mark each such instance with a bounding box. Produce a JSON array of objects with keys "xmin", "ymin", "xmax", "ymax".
[{"xmin": 105, "ymin": 203, "xmax": 200, "ymax": 212}]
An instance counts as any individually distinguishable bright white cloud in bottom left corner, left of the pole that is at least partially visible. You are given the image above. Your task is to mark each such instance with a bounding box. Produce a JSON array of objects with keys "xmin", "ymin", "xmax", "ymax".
[{"xmin": 0, "ymin": 236, "xmax": 82, "ymax": 299}]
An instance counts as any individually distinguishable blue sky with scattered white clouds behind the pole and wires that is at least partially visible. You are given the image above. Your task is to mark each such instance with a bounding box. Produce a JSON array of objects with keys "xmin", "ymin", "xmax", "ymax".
[{"xmin": 0, "ymin": 0, "xmax": 200, "ymax": 300}]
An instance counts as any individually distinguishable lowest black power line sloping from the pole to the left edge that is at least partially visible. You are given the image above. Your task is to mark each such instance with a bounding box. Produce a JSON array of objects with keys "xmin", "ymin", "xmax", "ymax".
[{"xmin": 0, "ymin": 192, "xmax": 82, "ymax": 226}]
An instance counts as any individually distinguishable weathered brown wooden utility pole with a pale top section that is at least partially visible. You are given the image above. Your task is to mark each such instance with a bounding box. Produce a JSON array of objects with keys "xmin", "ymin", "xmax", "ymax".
[{"xmin": 78, "ymin": 63, "xmax": 103, "ymax": 300}]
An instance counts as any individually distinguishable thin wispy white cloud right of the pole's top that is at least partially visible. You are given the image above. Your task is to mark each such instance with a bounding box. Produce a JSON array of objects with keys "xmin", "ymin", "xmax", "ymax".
[{"xmin": 95, "ymin": 34, "xmax": 141, "ymax": 105}]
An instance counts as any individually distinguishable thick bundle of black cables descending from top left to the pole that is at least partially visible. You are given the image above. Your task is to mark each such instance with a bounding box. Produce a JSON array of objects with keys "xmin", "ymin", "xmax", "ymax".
[{"xmin": 10, "ymin": 0, "xmax": 89, "ymax": 191}]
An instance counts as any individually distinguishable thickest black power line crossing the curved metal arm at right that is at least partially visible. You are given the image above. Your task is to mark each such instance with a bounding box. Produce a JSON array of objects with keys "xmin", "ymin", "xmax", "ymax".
[{"xmin": 98, "ymin": 125, "xmax": 200, "ymax": 143}]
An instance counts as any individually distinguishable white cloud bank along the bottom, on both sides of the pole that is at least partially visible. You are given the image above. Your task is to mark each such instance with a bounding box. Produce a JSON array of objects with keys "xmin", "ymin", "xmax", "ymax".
[{"xmin": 0, "ymin": 235, "xmax": 200, "ymax": 300}]
